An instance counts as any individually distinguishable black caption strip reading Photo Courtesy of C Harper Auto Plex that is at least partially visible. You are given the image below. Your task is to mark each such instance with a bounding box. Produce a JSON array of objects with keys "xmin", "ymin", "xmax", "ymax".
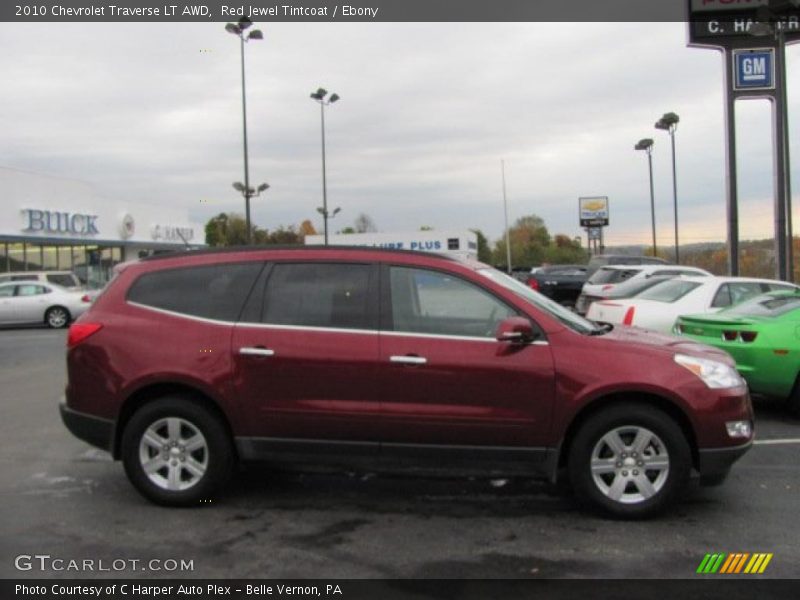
[{"xmin": 0, "ymin": 575, "xmax": 798, "ymax": 600}]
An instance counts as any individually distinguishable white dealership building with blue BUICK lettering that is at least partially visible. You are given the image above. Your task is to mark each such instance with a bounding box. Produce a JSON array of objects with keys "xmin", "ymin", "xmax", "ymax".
[{"xmin": 0, "ymin": 167, "xmax": 204, "ymax": 286}]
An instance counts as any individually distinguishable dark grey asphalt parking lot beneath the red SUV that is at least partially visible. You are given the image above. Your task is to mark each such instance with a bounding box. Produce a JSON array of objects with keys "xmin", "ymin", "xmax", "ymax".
[{"xmin": 0, "ymin": 329, "xmax": 800, "ymax": 578}]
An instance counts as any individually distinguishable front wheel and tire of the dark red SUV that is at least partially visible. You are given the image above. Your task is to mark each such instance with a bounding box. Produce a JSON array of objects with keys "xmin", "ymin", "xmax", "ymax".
[{"xmin": 567, "ymin": 403, "xmax": 692, "ymax": 519}]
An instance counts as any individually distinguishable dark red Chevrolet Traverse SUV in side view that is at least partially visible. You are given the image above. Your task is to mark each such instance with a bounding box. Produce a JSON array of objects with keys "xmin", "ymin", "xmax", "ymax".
[{"xmin": 61, "ymin": 247, "xmax": 753, "ymax": 517}]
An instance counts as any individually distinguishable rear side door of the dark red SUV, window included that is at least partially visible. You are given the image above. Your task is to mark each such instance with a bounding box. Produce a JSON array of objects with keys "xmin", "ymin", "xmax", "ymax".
[{"xmin": 232, "ymin": 262, "xmax": 380, "ymax": 454}]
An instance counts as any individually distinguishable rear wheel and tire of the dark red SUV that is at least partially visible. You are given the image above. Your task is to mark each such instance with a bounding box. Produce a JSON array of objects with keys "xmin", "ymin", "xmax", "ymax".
[{"xmin": 121, "ymin": 396, "xmax": 235, "ymax": 506}]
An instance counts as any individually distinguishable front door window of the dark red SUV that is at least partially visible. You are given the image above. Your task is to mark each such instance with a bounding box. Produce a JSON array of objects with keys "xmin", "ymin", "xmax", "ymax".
[{"xmin": 389, "ymin": 267, "xmax": 517, "ymax": 338}]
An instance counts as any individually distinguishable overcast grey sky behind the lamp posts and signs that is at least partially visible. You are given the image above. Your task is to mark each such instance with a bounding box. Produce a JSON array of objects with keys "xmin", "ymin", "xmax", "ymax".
[{"xmin": 0, "ymin": 23, "xmax": 800, "ymax": 245}]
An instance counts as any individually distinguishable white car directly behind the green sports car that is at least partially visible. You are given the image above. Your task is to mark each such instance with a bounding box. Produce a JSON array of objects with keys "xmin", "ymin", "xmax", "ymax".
[{"xmin": 586, "ymin": 276, "xmax": 800, "ymax": 333}]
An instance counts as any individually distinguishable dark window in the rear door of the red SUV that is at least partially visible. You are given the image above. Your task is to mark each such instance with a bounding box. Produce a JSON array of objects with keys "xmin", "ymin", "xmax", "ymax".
[{"xmin": 262, "ymin": 263, "xmax": 375, "ymax": 329}]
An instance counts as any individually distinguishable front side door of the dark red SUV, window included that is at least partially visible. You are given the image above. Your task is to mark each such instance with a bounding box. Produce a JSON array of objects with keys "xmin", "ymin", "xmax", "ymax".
[{"xmin": 378, "ymin": 265, "xmax": 554, "ymax": 458}]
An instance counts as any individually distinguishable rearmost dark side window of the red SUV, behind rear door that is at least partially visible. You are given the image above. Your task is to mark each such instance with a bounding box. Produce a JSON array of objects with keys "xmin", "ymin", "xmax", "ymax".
[{"xmin": 128, "ymin": 262, "xmax": 263, "ymax": 321}]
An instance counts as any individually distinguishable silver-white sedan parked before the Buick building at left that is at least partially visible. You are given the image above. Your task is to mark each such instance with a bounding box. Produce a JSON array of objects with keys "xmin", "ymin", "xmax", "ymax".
[{"xmin": 0, "ymin": 281, "xmax": 92, "ymax": 328}]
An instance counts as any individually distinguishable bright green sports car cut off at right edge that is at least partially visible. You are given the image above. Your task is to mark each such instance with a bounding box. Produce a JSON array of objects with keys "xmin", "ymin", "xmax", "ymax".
[{"xmin": 674, "ymin": 291, "xmax": 800, "ymax": 416}]
